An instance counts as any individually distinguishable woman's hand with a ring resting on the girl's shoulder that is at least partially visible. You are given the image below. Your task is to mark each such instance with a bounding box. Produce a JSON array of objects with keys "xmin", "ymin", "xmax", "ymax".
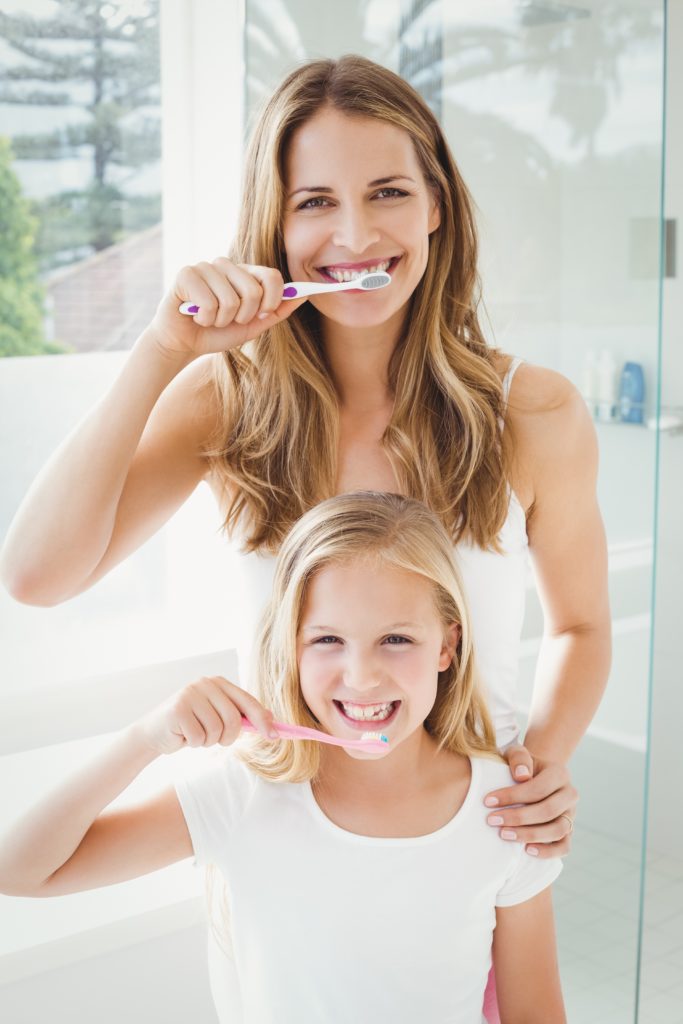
[{"xmin": 484, "ymin": 743, "xmax": 579, "ymax": 858}]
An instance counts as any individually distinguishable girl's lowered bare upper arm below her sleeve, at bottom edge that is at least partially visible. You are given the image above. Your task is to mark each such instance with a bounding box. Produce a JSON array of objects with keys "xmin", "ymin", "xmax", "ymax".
[{"xmin": 493, "ymin": 886, "xmax": 566, "ymax": 1024}]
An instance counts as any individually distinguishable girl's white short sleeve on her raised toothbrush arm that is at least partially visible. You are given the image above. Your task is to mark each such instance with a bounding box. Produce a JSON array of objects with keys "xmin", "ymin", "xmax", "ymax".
[{"xmin": 173, "ymin": 749, "xmax": 255, "ymax": 866}]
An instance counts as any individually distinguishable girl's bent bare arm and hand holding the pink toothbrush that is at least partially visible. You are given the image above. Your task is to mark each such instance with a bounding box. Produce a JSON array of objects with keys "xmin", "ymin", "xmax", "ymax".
[{"xmin": 0, "ymin": 676, "xmax": 272, "ymax": 896}]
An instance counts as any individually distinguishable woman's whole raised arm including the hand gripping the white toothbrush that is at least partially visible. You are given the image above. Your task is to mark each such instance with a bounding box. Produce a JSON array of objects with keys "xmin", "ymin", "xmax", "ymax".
[{"xmin": 0, "ymin": 258, "xmax": 306, "ymax": 605}]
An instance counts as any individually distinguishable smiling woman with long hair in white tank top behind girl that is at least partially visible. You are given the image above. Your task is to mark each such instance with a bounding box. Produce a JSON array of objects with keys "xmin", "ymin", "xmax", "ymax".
[{"xmin": 2, "ymin": 55, "xmax": 610, "ymax": 1015}]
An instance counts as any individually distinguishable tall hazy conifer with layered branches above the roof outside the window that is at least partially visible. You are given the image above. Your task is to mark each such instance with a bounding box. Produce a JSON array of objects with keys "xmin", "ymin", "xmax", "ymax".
[{"xmin": 0, "ymin": 0, "xmax": 160, "ymax": 268}]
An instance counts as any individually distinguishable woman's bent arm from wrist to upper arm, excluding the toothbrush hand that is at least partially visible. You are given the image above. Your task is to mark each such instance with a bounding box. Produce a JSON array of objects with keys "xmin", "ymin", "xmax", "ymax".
[{"xmin": 0, "ymin": 332, "xmax": 211, "ymax": 605}]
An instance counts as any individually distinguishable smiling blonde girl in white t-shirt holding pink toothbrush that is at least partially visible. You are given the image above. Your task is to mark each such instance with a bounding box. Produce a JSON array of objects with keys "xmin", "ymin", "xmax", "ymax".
[{"xmin": 0, "ymin": 492, "xmax": 566, "ymax": 1024}]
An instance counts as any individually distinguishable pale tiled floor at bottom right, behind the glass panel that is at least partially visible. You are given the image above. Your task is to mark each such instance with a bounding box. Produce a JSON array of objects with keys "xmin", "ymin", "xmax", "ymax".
[{"xmin": 553, "ymin": 824, "xmax": 683, "ymax": 1024}]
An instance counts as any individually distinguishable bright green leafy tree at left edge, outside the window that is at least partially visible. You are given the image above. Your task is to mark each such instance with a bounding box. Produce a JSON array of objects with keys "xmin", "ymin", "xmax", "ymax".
[{"xmin": 0, "ymin": 136, "xmax": 62, "ymax": 356}]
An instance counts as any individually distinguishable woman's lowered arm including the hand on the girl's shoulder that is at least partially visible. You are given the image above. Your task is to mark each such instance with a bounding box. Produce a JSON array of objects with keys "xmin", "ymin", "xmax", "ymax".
[{"xmin": 487, "ymin": 366, "xmax": 611, "ymax": 857}]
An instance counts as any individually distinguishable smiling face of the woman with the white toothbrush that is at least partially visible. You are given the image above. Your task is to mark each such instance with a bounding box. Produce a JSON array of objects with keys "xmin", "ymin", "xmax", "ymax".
[{"xmin": 283, "ymin": 108, "xmax": 440, "ymax": 327}]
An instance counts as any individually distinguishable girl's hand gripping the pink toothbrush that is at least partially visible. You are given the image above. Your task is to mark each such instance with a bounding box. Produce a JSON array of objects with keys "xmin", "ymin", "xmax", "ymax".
[{"xmin": 136, "ymin": 676, "xmax": 276, "ymax": 754}]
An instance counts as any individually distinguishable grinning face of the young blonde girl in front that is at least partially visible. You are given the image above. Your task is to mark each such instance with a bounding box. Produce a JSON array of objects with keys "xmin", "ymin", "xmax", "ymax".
[{"xmin": 297, "ymin": 561, "xmax": 460, "ymax": 758}]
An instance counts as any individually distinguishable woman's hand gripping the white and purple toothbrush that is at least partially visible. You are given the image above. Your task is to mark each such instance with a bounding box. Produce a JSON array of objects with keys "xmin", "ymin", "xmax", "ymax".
[{"xmin": 150, "ymin": 256, "xmax": 306, "ymax": 358}]
